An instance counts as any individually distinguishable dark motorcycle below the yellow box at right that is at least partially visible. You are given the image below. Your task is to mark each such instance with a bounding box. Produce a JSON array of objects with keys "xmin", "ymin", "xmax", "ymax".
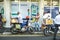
[{"xmin": 43, "ymin": 25, "xmax": 55, "ymax": 36}]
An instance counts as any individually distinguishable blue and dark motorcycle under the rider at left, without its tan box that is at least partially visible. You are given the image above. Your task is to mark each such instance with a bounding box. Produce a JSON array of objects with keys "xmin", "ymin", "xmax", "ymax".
[{"xmin": 11, "ymin": 19, "xmax": 32, "ymax": 34}]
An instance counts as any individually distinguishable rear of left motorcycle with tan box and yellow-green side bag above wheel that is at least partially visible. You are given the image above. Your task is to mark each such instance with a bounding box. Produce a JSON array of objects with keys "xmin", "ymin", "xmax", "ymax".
[{"xmin": 10, "ymin": 18, "xmax": 21, "ymax": 34}]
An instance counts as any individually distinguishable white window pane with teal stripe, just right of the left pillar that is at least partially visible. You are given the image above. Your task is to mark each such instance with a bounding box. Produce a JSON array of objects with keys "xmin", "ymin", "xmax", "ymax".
[{"xmin": 11, "ymin": 1, "xmax": 19, "ymax": 18}]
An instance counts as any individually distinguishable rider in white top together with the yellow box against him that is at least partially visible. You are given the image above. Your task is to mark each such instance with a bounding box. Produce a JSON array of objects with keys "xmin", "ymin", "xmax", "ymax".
[{"xmin": 43, "ymin": 11, "xmax": 53, "ymax": 33}]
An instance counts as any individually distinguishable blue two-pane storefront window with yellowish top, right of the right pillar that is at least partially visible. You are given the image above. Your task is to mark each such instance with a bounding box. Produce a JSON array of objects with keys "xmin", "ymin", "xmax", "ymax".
[{"xmin": 44, "ymin": 0, "xmax": 59, "ymax": 18}]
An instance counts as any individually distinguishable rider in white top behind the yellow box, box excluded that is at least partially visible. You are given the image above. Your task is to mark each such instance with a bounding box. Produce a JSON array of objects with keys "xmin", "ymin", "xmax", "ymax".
[{"xmin": 43, "ymin": 11, "xmax": 53, "ymax": 33}]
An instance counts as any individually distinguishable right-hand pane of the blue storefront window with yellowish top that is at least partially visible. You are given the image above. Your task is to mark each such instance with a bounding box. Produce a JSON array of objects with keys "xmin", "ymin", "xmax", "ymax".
[{"xmin": 51, "ymin": 0, "xmax": 59, "ymax": 18}]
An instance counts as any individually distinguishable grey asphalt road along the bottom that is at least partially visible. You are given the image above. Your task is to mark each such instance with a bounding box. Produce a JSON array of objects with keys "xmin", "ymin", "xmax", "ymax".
[{"xmin": 0, "ymin": 36, "xmax": 60, "ymax": 40}]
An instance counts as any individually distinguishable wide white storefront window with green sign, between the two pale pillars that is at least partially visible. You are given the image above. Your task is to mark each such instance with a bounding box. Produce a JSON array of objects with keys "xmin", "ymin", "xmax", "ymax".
[{"xmin": 11, "ymin": 0, "xmax": 39, "ymax": 18}]
